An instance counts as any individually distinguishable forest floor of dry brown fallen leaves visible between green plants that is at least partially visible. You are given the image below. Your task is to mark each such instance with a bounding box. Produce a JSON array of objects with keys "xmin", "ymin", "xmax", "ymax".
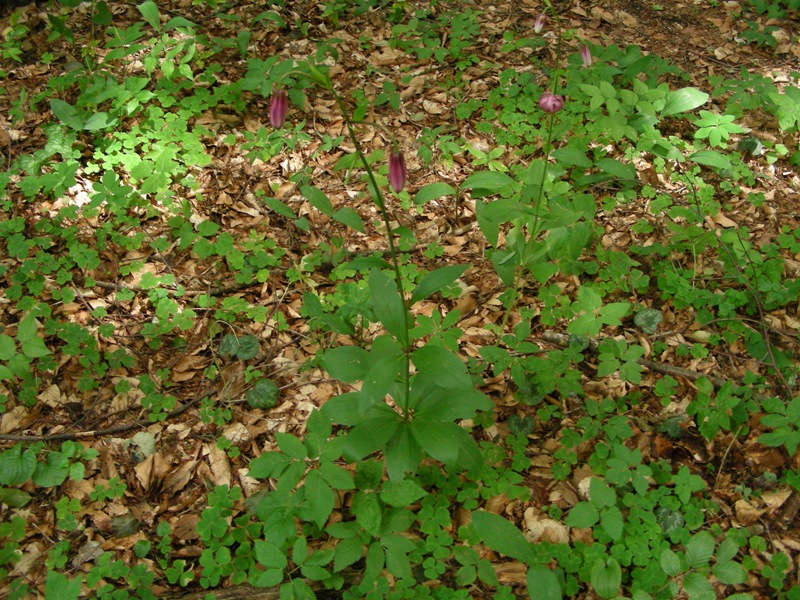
[{"xmin": 0, "ymin": 0, "xmax": 800, "ymax": 598}]
